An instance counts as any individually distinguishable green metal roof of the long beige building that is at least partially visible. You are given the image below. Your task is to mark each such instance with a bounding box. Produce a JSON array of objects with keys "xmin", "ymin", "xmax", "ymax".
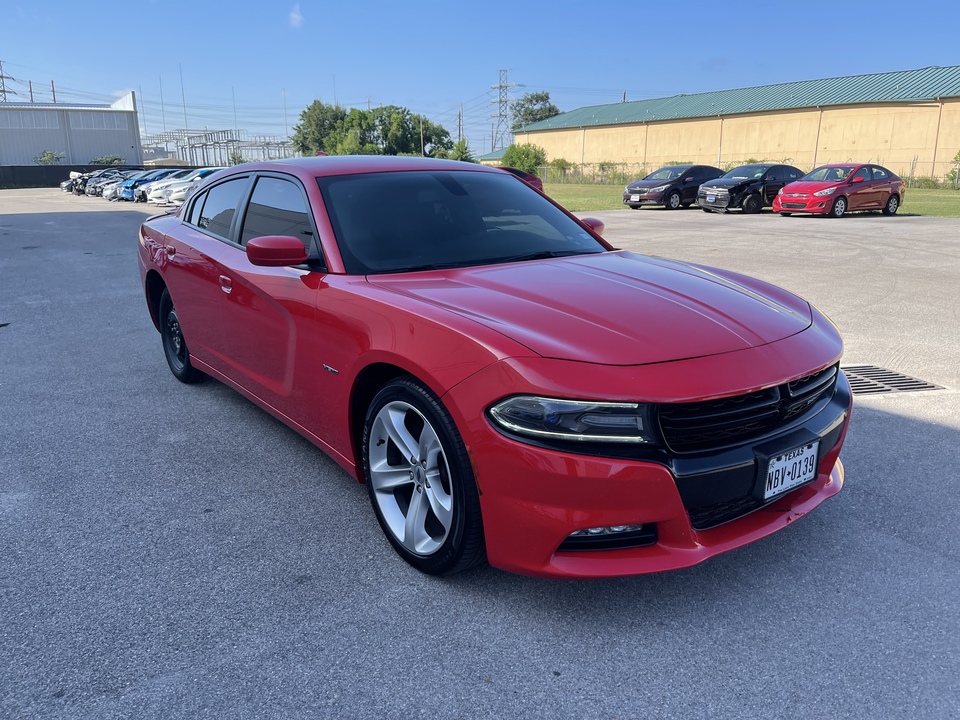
[{"xmin": 517, "ymin": 65, "xmax": 960, "ymax": 132}]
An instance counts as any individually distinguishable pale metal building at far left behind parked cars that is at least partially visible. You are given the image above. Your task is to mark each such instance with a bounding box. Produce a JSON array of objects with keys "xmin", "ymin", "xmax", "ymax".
[{"xmin": 0, "ymin": 92, "xmax": 143, "ymax": 165}]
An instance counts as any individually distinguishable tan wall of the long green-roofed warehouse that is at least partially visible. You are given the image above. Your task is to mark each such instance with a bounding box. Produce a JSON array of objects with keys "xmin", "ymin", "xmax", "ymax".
[{"xmin": 515, "ymin": 98, "xmax": 960, "ymax": 177}]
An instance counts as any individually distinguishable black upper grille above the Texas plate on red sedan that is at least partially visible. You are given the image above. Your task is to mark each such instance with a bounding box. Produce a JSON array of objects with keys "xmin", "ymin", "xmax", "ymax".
[{"xmin": 657, "ymin": 366, "xmax": 837, "ymax": 453}]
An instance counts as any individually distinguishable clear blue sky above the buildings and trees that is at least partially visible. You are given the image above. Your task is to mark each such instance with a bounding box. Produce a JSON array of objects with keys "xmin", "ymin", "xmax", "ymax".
[{"xmin": 7, "ymin": 0, "xmax": 960, "ymax": 153}]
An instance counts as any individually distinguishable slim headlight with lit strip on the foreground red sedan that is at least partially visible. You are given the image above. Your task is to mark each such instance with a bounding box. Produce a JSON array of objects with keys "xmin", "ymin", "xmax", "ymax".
[{"xmin": 490, "ymin": 395, "xmax": 656, "ymax": 444}]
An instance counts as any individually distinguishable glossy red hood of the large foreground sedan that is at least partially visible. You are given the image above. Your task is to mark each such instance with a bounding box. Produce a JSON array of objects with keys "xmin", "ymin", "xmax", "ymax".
[{"xmin": 369, "ymin": 251, "xmax": 812, "ymax": 365}]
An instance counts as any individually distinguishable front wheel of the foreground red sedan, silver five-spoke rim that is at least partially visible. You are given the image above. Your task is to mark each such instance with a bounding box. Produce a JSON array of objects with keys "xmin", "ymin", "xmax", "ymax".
[{"xmin": 363, "ymin": 377, "xmax": 486, "ymax": 575}]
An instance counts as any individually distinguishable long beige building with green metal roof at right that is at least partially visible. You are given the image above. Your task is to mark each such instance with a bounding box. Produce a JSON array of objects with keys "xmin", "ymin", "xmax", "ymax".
[{"xmin": 514, "ymin": 66, "xmax": 960, "ymax": 179}]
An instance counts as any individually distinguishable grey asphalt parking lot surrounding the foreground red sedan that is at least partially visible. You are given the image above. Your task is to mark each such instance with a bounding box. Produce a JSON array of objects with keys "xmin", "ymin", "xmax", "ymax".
[{"xmin": 0, "ymin": 190, "xmax": 960, "ymax": 719}]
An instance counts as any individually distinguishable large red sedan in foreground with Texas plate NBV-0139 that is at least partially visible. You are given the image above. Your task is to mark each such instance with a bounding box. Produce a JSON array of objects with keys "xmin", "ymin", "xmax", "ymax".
[{"xmin": 139, "ymin": 157, "xmax": 851, "ymax": 577}]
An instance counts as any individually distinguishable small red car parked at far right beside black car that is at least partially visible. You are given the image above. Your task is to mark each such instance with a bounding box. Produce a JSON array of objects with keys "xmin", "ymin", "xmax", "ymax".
[{"xmin": 773, "ymin": 163, "xmax": 906, "ymax": 217}]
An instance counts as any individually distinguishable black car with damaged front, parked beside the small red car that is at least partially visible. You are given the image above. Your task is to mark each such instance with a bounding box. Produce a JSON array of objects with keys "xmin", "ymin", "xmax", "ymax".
[{"xmin": 697, "ymin": 163, "xmax": 803, "ymax": 213}]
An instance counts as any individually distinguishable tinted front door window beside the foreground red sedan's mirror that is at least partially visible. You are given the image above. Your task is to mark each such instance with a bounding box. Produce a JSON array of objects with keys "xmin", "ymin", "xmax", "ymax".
[{"xmin": 240, "ymin": 177, "xmax": 313, "ymax": 252}]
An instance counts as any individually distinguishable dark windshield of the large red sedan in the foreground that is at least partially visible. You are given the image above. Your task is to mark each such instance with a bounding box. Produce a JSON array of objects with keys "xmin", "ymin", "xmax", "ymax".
[{"xmin": 317, "ymin": 170, "xmax": 607, "ymax": 276}]
